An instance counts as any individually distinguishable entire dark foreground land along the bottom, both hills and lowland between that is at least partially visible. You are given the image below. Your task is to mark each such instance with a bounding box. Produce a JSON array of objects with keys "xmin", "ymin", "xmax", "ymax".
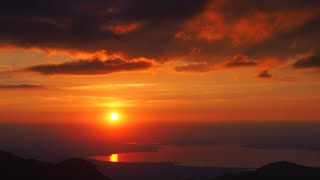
[{"xmin": 0, "ymin": 151, "xmax": 320, "ymax": 180}]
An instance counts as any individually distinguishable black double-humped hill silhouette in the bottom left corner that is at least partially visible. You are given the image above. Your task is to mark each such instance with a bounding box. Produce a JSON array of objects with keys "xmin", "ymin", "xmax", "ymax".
[{"xmin": 0, "ymin": 151, "xmax": 110, "ymax": 180}]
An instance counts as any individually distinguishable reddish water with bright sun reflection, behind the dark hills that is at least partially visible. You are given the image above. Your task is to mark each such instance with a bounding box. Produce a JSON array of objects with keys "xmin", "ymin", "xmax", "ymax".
[{"xmin": 90, "ymin": 145, "xmax": 320, "ymax": 168}]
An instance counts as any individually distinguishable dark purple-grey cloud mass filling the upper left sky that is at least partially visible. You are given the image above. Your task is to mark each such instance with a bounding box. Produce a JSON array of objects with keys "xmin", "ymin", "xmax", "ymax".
[{"xmin": 0, "ymin": 0, "xmax": 207, "ymax": 57}]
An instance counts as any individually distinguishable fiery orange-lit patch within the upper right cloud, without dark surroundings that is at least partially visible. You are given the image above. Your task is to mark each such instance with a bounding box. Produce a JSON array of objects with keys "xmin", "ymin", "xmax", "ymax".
[{"xmin": 175, "ymin": 1, "xmax": 318, "ymax": 46}]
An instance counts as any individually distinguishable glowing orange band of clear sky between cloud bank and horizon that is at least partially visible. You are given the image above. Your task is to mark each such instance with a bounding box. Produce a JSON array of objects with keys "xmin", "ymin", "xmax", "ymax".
[{"xmin": 0, "ymin": 49, "xmax": 320, "ymax": 123}]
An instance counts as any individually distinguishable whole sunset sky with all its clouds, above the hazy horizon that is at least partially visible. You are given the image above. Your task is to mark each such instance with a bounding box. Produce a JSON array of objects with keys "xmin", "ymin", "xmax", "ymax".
[{"xmin": 0, "ymin": 0, "xmax": 320, "ymax": 124}]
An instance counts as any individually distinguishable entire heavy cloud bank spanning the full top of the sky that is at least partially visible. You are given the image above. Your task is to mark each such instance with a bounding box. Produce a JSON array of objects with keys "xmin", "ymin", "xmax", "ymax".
[{"xmin": 0, "ymin": 0, "xmax": 320, "ymax": 67}]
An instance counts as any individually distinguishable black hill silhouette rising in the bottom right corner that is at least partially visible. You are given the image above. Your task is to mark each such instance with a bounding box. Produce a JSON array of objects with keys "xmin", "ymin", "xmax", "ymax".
[{"xmin": 212, "ymin": 161, "xmax": 320, "ymax": 180}]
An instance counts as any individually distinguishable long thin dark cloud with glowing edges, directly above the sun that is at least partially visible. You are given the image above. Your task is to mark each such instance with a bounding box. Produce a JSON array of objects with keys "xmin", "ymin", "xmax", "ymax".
[{"xmin": 26, "ymin": 59, "xmax": 152, "ymax": 75}]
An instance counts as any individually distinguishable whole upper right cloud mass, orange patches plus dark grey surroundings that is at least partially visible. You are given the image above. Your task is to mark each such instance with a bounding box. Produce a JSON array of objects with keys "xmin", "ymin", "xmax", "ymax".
[{"xmin": 175, "ymin": 0, "xmax": 320, "ymax": 68}]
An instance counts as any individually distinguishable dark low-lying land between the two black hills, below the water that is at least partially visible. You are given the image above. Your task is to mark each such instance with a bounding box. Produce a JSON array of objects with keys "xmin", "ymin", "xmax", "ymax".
[{"xmin": 92, "ymin": 161, "xmax": 246, "ymax": 180}]
